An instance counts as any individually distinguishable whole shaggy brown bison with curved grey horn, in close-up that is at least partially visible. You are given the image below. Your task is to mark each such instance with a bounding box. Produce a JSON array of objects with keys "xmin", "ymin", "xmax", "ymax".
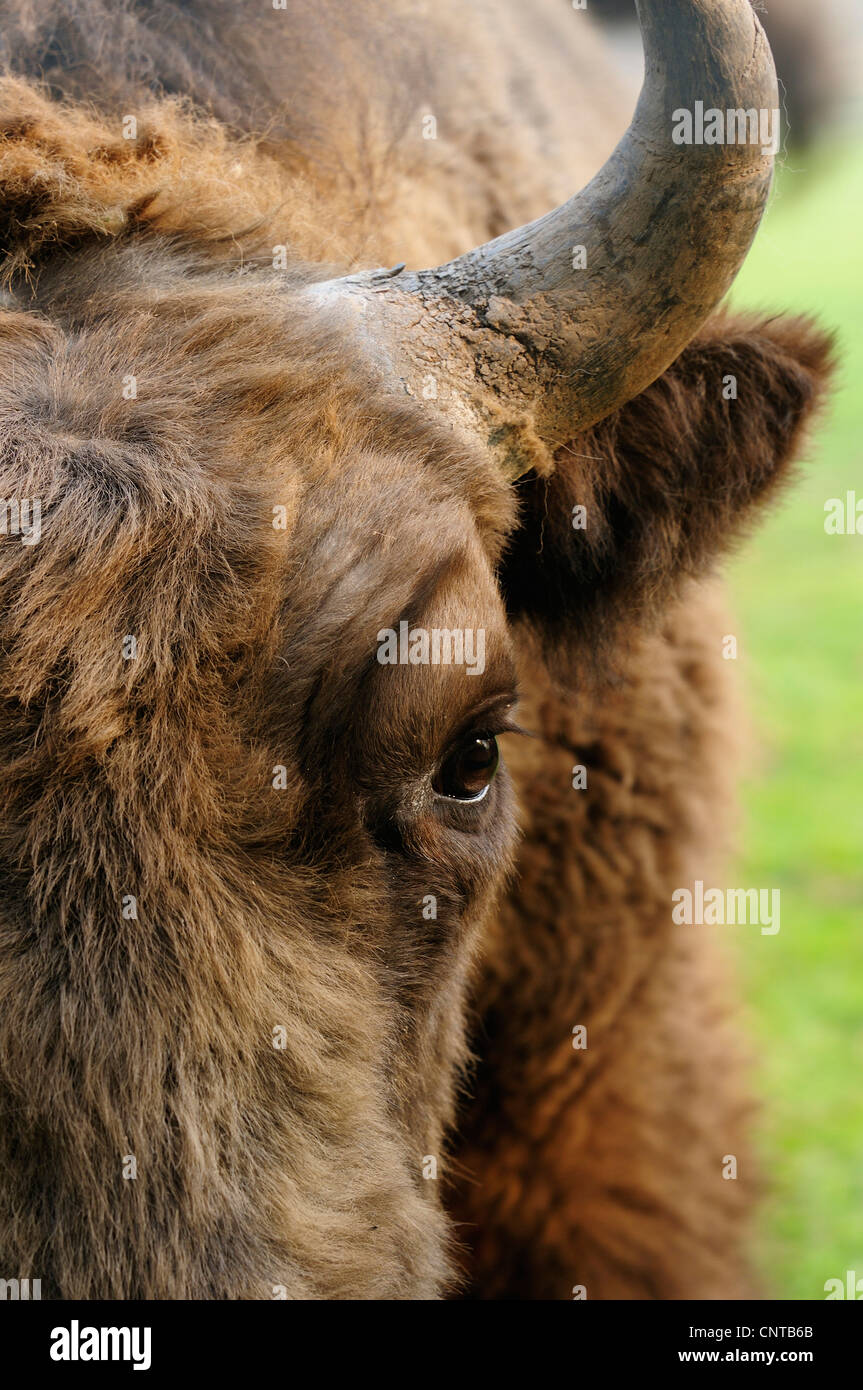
[{"xmin": 0, "ymin": 0, "xmax": 831, "ymax": 1300}]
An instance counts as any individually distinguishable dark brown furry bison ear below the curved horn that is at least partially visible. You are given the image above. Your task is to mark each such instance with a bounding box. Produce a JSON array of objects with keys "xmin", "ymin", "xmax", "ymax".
[{"xmin": 502, "ymin": 317, "xmax": 832, "ymax": 669}]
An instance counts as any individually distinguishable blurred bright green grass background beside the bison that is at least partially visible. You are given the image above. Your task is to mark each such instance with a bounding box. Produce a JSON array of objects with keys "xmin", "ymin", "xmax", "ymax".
[{"xmin": 600, "ymin": 0, "xmax": 863, "ymax": 1298}]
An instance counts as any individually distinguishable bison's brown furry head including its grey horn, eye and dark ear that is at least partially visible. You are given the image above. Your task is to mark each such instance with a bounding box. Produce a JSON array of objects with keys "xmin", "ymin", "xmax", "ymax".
[{"xmin": 0, "ymin": 0, "xmax": 827, "ymax": 1297}]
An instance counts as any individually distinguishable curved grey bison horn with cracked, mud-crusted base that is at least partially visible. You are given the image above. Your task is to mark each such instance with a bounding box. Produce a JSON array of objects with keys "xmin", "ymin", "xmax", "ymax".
[{"xmin": 308, "ymin": 0, "xmax": 778, "ymax": 477}]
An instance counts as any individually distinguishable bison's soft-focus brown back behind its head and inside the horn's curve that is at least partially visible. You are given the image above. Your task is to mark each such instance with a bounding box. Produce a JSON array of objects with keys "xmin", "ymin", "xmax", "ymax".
[{"xmin": 0, "ymin": 0, "xmax": 623, "ymax": 276}]
